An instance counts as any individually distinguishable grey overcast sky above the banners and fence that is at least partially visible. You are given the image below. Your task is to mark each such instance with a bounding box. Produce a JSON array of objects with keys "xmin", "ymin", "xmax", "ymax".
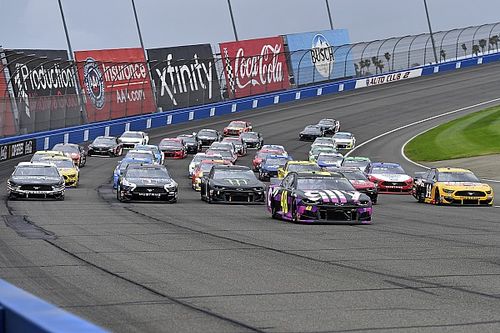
[{"xmin": 0, "ymin": 0, "xmax": 500, "ymax": 50}]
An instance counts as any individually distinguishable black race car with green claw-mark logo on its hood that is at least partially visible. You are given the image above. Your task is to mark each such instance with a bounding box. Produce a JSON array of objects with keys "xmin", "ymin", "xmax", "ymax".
[{"xmin": 201, "ymin": 165, "xmax": 266, "ymax": 204}]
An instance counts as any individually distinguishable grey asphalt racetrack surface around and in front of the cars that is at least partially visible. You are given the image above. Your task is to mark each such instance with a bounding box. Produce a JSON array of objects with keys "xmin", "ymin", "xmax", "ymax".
[{"xmin": 0, "ymin": 64, "xmax": 500, "ymax": 332}]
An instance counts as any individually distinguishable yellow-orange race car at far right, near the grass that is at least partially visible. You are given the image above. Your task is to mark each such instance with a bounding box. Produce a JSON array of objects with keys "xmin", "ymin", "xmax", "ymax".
[{"xmin": 412, "ymin": 168, "xmax": 494, "ymax": 206}]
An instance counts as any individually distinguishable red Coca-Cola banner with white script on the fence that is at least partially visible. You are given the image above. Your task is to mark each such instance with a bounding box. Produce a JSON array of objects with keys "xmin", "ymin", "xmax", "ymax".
[{"xmin": 219, "ymin": 36, "xmax": 290, "ymax": 98}]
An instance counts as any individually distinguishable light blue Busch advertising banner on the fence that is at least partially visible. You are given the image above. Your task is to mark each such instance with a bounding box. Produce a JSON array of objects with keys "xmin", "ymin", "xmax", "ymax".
[{"xmin": 285, "ymin": 29, "xmax": 356, "ymax": 86}]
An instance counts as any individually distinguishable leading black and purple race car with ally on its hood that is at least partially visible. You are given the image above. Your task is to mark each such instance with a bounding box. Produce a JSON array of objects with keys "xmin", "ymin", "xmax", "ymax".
[{"xmin": 266, "ymin": 172, "xmax": 372, "ymax": 224}]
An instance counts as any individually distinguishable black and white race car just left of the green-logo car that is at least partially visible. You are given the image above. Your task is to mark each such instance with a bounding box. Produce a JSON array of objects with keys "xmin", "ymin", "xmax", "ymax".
[{"xmin": 116, "ymin": 164, "xmax": 178, "ymax": 202}]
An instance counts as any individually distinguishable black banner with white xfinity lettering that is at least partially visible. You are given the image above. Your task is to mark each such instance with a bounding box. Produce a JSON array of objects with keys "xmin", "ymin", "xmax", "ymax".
[{"xmin": 147, "ymin": 44, "xmax": 221, "ymax": 110}]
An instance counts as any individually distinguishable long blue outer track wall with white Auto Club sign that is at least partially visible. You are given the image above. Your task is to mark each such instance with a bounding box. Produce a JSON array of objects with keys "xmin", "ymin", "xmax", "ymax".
[{"xmin": 0, "ymin": 53, "xmax": 500, "ymax": 161}]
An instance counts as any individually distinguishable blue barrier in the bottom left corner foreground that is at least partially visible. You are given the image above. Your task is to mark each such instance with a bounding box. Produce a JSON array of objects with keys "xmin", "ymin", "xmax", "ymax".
[{"xmin": 0, "ymin": 280, "xmax": 107, "ymax": 333}]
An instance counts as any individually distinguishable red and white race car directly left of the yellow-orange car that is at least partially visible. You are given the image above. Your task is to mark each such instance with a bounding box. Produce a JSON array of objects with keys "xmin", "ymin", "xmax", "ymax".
[{"xmin": 365, "ymin": 162, "xmax": 413, "ymax": 194}]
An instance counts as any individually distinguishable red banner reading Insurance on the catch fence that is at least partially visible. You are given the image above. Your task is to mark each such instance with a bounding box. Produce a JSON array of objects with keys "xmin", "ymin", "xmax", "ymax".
[{"xmin": 75, "ymin": 48, "xmax": 156, "ymax": 122}]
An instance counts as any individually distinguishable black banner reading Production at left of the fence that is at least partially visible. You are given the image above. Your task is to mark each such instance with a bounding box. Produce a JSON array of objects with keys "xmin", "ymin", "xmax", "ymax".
[{"xmin": 5, "ymin": 50, "xmax": 81, "ymax": 133}]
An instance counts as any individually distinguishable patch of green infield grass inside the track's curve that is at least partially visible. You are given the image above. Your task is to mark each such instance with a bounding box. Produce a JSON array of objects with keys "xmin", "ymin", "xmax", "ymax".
[{"xmin": 405, "ymin": 106, "xmax": 500, "ymax": 162}]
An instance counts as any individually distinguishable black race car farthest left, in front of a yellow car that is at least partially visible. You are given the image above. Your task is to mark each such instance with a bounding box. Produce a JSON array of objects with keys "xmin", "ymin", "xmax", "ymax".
[{"xmin": 7, "ymin": 162, "xmax": 66, "ymax": 200}]
